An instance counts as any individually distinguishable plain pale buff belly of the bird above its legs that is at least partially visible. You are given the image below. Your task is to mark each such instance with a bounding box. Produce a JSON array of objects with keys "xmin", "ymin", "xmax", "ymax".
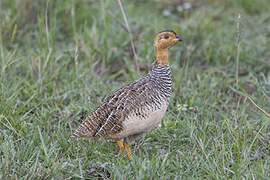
[{"xmin": 110, "ymin": 102, "xmax": 168, "ymax": 138}]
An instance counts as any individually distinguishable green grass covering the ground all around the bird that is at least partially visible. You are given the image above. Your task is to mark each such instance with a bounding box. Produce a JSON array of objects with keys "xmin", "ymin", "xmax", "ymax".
[{"xmin": 0, "ymin": 0, "xmax": 270, "ymax": 179}]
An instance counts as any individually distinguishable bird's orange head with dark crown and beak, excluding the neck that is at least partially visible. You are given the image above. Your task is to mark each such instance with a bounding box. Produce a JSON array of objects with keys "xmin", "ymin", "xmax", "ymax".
[{"xmin": 154, "ymin": 30, "xmax": 182, "ymax": 50}]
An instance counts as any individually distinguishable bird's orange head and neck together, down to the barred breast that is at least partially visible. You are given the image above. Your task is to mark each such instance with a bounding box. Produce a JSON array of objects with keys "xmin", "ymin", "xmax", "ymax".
[{"xmin": 154, "ymin": 30, "xmax": 182, "ymax": 64}]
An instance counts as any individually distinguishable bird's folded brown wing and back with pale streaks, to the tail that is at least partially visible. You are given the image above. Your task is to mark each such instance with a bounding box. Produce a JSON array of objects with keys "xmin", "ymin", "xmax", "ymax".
[{"xmin": 70, "ymin": 76, "xmax": 152, "ymax": 140}]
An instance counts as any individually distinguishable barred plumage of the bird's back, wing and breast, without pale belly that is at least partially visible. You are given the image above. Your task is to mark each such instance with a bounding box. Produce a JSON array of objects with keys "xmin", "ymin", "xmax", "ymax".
[{"xmin": 70, "ymin": 64, "xmax": 172, "ymax": 140}]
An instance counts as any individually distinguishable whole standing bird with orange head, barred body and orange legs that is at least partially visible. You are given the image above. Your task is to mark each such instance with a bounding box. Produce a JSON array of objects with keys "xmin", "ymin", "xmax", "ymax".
[{"xmin": 69, "ymin": 30, "xmax": 182, "ymax": 158}]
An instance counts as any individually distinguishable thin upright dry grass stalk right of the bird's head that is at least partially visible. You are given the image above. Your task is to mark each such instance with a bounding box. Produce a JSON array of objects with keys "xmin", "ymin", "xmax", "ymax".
[{"xmin": 235, "ymin": 13, "xmax": 241, "ymax": 87}]
